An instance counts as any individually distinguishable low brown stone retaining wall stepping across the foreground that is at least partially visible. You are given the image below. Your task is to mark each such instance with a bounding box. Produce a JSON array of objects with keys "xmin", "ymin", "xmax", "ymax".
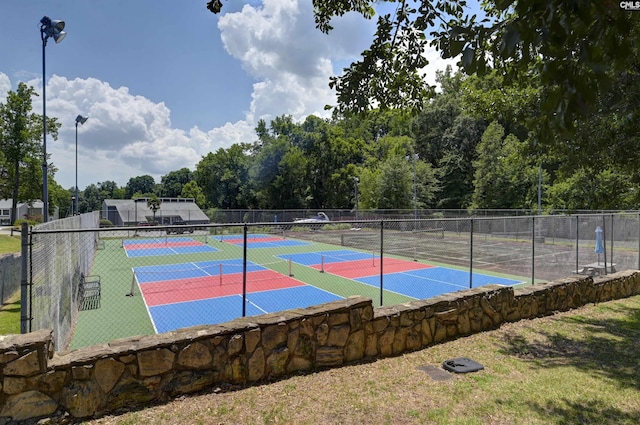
[{"xmin": 0, "ymin": 271, "xmax": 640, "ymax": 423}]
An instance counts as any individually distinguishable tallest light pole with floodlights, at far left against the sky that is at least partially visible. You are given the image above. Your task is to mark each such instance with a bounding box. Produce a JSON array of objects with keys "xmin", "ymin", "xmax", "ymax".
[{"xmin": 40, "ymin": 16, "xmax": 67, "ymax": 223}]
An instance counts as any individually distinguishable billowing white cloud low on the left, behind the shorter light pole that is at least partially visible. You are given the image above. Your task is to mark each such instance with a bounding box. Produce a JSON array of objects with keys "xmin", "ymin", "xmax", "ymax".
[{"xmin": 31, "ymin": 75, "xmax": 200, "ymax": 188}]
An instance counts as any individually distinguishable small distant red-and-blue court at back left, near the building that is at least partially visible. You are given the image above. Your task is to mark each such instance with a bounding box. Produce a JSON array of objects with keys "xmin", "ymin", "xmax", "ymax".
[{"xmin": 122, "ymin": 237, "xmax": 218, "ymax": 258}]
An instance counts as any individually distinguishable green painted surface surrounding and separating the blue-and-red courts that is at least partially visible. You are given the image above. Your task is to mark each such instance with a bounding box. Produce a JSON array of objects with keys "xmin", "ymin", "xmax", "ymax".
[{"xmin": 69, "ymin": 235, "xmax": 522, "ymax": 349}]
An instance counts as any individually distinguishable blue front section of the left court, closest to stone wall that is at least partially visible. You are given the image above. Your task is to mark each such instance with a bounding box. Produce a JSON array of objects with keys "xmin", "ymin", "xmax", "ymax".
[{"xmin": 149, "ymin": 285, "xmax": 342, "ymax": 333}]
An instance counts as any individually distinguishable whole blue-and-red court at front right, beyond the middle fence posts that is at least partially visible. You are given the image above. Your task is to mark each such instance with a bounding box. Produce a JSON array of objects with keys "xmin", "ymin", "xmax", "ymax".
[{"xmin": 279, "ymin": 250, "xmax": 524, "ymax": 299}]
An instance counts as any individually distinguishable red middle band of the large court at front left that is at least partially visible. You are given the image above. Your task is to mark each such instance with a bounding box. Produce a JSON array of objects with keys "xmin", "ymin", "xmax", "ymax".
[{"xmin": 140, "ymin": 270, "xmax": 304, "ymax": 307}]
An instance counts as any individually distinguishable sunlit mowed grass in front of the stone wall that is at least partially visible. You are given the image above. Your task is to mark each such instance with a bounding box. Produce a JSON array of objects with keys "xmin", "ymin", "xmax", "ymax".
[{"xmin": 86, "ymin": 296, "xmax": 640, "ymax": 425}]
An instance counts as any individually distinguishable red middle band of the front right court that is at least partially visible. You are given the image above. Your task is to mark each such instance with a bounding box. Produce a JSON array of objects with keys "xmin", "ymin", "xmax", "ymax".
[{"xmin": 311, "ymin": 257, "xmax": 434, "ymax": 279}]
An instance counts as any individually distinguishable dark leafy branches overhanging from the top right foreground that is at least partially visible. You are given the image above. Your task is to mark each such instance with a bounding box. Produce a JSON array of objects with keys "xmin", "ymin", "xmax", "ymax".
[{"xmin": 207, "ymin": 0, "xmax": 640, "ymax": 138}]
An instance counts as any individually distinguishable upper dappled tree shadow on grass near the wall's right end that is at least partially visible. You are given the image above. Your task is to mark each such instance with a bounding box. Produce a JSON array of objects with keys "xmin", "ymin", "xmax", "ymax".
[{"xmin": 500, "ymin": 303, "xmax": 640, "ymax": 388}]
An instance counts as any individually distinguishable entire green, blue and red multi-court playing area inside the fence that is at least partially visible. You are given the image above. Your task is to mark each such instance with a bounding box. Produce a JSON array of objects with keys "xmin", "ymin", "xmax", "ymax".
[{"xmin": 71, "ymin": 234, "xmax": 520, "ymax": 348}]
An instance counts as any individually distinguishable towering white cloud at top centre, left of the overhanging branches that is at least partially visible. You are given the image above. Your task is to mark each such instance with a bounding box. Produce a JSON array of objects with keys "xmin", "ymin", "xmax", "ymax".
[{"xmin": 218, "ymin": 0, "xmax": 372, "ymax": 122}]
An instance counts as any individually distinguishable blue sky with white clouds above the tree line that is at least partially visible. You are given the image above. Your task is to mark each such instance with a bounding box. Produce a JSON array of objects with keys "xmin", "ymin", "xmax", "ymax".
[{"xmin": 0, "ymin": 0, "xmax": 455, "ymax": 190}]
